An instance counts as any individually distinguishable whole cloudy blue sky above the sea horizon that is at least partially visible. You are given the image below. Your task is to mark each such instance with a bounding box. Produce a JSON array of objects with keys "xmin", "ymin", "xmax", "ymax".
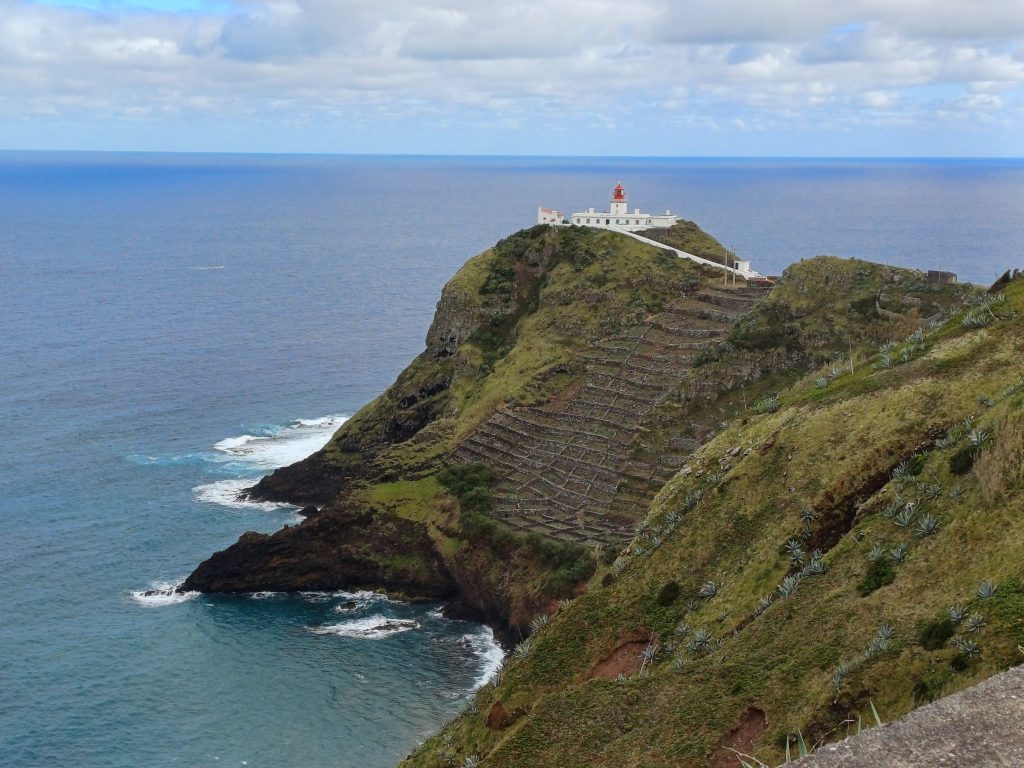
[{"xmin": 0, "ymin": 0, "xmax": 1024, "ymax": 157}]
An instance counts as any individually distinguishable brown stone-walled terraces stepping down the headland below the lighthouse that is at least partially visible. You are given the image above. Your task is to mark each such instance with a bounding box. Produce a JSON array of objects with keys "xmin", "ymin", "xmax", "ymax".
[{"xmin": 453, "ymin": 287, "xmax": 765, "ymax": 547}]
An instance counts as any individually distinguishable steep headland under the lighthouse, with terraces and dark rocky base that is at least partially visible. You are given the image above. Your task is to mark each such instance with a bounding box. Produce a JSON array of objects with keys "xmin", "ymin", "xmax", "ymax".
[{"xmin": 183, "ymin": 222, "xmax": 978, "ymax": 655}]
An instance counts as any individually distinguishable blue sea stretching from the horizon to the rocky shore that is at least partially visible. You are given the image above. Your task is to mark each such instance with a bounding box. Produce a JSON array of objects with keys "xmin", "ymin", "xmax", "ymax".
[{"xmin": 0, "ymin": 153, "xmax": 1024, "ymax": 768}]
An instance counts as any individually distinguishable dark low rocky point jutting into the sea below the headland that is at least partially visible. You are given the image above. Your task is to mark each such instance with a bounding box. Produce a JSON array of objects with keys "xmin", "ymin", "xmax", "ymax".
[{"xmin": 178, "ymin": 509, "xmax": 456, "ymax": 599}]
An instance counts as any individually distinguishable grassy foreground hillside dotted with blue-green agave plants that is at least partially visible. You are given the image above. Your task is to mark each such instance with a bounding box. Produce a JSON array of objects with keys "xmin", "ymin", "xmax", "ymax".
[{"xmin": 409, "ymin": 274, "xmax": 1024, "ymax": 766}]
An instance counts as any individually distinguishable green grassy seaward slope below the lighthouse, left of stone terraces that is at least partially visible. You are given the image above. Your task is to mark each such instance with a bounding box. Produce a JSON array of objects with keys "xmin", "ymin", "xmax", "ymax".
[{"xmin": 325, "ymin": 222, "xmax": 733, "ymax": 631}]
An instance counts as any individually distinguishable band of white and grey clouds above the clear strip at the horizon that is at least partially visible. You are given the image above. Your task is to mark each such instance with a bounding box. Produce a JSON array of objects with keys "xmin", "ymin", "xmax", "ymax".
[{"xmin": 0, "ymin": 0, "xmax": 1024, "ymax": 151}]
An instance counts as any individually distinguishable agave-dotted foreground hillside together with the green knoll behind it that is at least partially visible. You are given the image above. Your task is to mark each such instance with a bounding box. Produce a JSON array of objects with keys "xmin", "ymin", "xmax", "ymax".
[{"xmin": 408, "ymin": 274, "xmax": 1024, "ymax": 767}]
